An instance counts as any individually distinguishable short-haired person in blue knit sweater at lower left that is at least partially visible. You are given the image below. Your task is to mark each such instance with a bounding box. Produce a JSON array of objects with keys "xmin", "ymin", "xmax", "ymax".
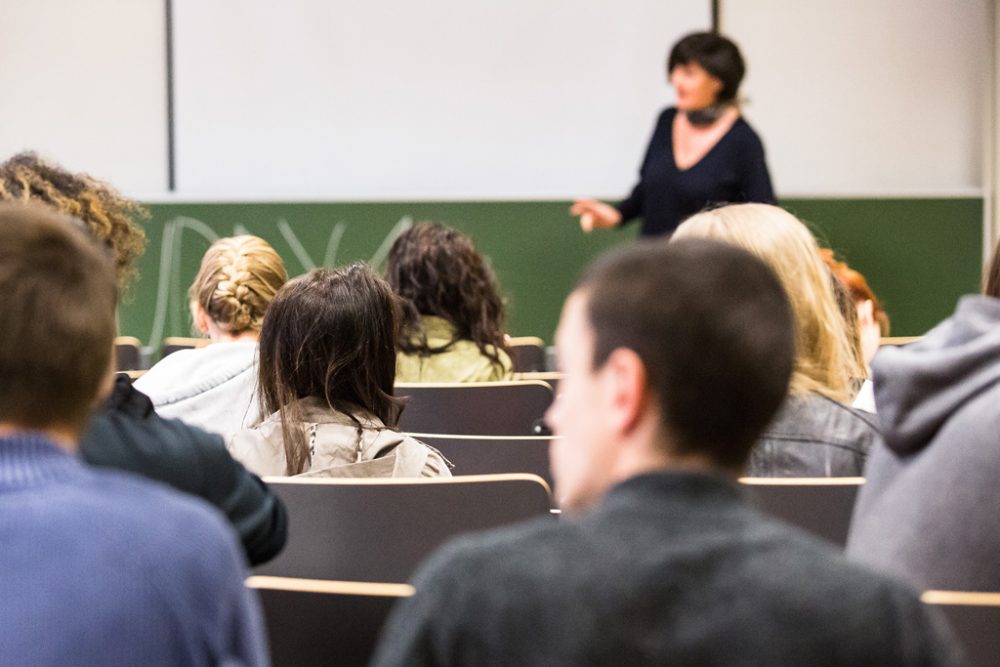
[{"xmin": 0, "ymin": 203, "xmax": 267, "ymax": 666}]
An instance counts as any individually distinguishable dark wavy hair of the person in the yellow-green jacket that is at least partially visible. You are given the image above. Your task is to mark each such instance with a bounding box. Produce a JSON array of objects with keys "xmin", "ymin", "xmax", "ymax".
[{"xmin": 388, "ymin": 222, "xmax": 506, "ymax": 366}]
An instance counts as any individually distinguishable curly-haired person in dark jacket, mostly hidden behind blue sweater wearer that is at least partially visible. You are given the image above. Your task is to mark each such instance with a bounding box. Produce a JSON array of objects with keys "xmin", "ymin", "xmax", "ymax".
[{"xmin": 0, "ymin": 153, "xmax": 288, "ymax": 564}]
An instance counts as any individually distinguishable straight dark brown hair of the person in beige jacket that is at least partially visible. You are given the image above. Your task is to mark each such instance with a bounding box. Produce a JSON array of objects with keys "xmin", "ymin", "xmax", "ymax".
[{"xmin": 258, "ymin": 263, "xmax": 400, "ymax": 475}]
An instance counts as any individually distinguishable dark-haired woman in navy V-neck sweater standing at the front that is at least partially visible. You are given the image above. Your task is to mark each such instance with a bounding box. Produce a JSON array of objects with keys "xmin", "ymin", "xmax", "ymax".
[{"xmin": 570, "ymin": 32, "xmax": 775, "ymax": 236}]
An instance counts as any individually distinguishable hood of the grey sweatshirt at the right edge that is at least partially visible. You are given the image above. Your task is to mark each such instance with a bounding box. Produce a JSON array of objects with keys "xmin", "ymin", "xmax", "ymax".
[{"xmin": 872, "ymin": 296, "xmax": 1000, "ymax": 455}]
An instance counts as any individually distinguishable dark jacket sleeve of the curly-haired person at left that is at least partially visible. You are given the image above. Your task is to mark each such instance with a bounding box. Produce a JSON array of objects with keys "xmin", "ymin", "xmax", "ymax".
[{"xmin": 80, "ymin": 375, "xmax": 288, "ymax": 565}]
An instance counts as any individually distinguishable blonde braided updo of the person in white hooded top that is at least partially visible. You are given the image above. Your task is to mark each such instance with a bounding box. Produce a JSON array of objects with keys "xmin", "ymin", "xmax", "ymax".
[{"xmin": 188, "ymin": 235, "xmax": 288, "ymax": 335}]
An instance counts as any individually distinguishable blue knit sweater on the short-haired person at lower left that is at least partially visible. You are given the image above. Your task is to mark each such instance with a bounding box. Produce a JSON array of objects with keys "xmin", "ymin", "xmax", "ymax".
[{"xmin": 0, "ymin": 435, "xmax": 267, "ymax": 665}]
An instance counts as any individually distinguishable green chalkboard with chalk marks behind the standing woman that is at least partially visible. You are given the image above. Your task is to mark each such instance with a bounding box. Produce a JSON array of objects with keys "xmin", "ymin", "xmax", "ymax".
[{"xmin": 120, "ymin": 199, "xmax": 982, "ymax": 347}]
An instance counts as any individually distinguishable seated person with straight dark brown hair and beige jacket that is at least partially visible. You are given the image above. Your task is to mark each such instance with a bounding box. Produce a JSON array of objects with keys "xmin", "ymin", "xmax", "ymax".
[{"xmin": 229, "ymin": 264, "xmax": 451, "ymax": 477}]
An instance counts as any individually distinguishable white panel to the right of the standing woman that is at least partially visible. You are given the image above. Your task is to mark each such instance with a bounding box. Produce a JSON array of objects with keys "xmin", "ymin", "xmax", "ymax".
[{"xmin": 722, "ymin": 0, "xmax": 992, "ymax": 197}]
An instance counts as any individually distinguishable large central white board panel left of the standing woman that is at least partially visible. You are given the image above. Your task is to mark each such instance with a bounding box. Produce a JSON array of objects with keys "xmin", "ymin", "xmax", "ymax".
[{"xmin": 173, "ymin": 0, "xmax": 710, "ymax": 200}]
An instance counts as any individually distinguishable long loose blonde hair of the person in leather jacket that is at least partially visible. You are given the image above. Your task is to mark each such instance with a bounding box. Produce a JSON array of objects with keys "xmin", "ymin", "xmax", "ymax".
[{"xmin": 673, "ymin": 204, "xmax": 866, "ymax": 402}]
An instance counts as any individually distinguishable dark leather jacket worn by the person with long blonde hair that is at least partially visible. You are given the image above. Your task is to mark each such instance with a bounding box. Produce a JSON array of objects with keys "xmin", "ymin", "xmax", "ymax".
[{"xmin": 746, "ymin": 394, "xmax": 881, "ymax": 477}]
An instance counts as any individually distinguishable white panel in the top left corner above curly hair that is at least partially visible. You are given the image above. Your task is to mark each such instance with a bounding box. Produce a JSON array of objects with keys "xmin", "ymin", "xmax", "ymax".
[{"xmin": 0, "ymin": 0, "xmax": 167, "ymax": 194}]
